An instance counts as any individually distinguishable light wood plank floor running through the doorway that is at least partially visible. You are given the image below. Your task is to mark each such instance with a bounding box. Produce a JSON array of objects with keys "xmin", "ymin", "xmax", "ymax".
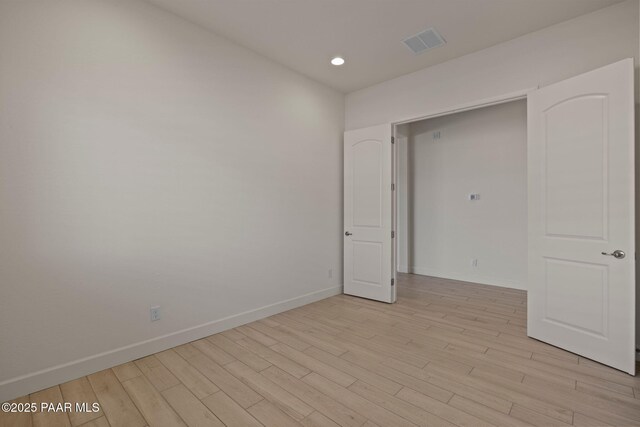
[{"xmin": 0, "ymin": 275, "xmax": 640, "ymax": 427}]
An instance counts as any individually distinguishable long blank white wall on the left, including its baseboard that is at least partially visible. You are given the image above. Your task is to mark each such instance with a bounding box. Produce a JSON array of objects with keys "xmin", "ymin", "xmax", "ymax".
[{"xmin": 0, "ymin": 0, "xmax": 344, "ymax": 401}]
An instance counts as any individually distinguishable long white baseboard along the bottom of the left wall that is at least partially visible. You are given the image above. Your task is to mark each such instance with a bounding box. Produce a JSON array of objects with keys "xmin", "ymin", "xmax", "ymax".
[{"xmin": 0, "ymin": 285, "xmax": 342, "ymax": 402}]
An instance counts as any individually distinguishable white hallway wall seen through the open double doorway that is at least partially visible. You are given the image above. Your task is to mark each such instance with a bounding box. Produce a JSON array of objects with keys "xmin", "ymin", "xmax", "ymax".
[{"xmin": 399, "ymin": 101, "xmax": 527, "ymax": 289}]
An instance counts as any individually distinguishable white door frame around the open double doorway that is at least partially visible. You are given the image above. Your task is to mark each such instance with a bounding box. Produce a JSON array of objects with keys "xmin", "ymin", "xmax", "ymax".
[{"xmin": 391, "ymin": 86, "xmax": 540, "ymax": 280}]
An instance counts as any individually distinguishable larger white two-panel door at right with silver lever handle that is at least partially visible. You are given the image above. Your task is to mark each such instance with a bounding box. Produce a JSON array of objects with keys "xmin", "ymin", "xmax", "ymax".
[{"xmin": 528, "ymin": 59, "xmax": 636, "ymax": 375}]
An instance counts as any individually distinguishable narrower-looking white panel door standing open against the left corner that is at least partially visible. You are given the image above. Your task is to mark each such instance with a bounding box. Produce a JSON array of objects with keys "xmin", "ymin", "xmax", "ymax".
[{"xmin": 344, "ymin": 125, "xmax": 396, "ymax": 303}]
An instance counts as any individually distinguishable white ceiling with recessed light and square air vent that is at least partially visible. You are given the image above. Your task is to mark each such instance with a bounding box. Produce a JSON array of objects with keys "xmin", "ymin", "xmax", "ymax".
[{"xmin": 148, "ymin": 0, "xmax": 621, "ymax": 92}]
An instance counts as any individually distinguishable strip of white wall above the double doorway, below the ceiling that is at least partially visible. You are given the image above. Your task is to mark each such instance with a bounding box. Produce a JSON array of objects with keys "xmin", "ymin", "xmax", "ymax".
[{"xmin": 346, "ymin": 0, "xmax": 639, "ymax": 129}]
